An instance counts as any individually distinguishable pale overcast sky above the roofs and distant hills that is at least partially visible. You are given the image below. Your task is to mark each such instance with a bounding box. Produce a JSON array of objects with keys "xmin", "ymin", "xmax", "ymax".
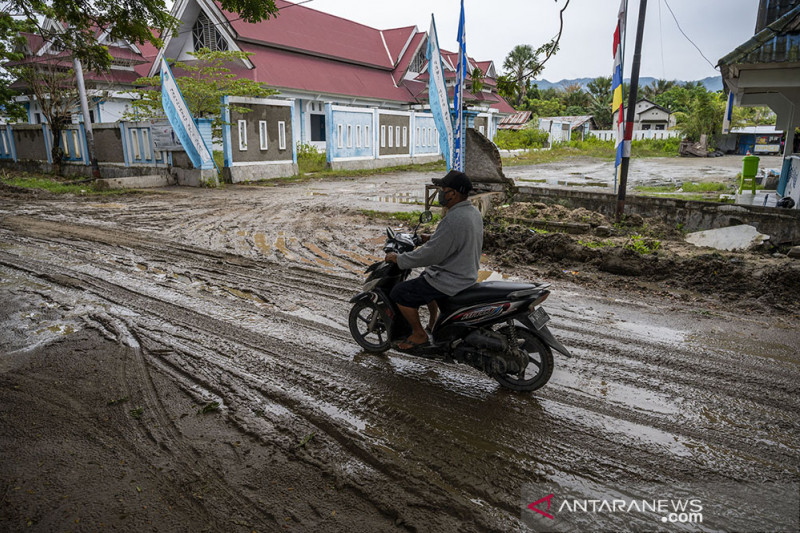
[{"xmin": 298, "ymin": 0, "xmax": 758, "ymax": 81}]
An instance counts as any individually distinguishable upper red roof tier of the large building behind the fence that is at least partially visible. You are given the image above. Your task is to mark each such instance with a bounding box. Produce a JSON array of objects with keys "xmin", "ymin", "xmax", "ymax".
[{"xmin": 217, "ymin": 0, "xmax": 394, "ymax": 70}]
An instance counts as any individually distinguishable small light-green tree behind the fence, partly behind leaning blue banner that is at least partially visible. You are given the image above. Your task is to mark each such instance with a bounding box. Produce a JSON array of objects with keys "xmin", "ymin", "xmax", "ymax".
[{"xmin": 123, "ymin": 49, "xmax": 277, "ymax": 137}]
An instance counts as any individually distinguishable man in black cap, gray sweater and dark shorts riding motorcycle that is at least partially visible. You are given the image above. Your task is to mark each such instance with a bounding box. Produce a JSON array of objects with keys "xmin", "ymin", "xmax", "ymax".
[{"xmin": 384, "ymin": 170, "xmax": 483, "ymax": 351}]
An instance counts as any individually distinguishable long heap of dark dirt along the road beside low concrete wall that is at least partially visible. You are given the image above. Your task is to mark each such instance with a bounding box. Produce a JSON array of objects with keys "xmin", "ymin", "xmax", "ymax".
[{"xmin": 484, "ymin": 220, "xmax": 800, "ymax": 307}]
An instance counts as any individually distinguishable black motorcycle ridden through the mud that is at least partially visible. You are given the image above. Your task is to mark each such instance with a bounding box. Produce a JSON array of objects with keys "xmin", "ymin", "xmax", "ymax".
[{"xmin": 348, "ymin": 211, "xmax": 572, "ymax": 391}]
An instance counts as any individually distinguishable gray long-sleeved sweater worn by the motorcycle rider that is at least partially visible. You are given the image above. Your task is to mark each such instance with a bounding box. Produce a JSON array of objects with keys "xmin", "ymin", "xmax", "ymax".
[{"xmin": 397, "ymin": 200, "xmax": 483, "ymax": 296}]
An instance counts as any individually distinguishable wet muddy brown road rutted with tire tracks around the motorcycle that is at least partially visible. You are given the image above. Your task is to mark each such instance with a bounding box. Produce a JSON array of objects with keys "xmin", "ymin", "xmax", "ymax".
[{"xmin": 0, "ymin": 168, "xmax": 800, "ymax": 532}]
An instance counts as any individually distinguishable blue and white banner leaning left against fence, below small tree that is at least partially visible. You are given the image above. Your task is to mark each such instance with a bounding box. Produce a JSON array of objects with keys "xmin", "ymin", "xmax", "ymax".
[{"xmin": 161, "ymin": 57, "xmax": 215, "ymax": 169}]
